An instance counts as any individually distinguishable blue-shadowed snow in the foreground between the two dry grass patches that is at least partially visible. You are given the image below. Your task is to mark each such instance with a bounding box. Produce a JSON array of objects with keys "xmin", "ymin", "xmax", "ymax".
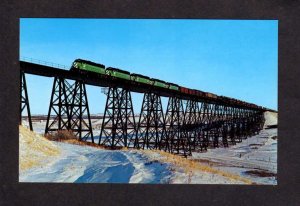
[{"xmin": 19, "ymin": 142, "xmax": 171, "ymax": 183}]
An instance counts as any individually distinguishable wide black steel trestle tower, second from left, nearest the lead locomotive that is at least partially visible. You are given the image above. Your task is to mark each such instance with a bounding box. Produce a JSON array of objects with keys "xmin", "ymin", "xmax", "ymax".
[{"xmin": 45, "ymin": 77, "xmax": 94, "ymax": 142}]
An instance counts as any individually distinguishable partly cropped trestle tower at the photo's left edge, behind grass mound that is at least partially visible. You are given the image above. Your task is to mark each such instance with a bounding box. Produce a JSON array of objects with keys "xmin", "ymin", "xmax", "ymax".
[{"xmin": 19, "ymin": 70, "xmax": 33, "ymax": 131}]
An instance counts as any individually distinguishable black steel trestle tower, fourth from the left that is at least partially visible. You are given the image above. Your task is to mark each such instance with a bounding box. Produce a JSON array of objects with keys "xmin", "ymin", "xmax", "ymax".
[{"xmin": 135, "ymin": 92, "xmax": 166, "ymax": 149}]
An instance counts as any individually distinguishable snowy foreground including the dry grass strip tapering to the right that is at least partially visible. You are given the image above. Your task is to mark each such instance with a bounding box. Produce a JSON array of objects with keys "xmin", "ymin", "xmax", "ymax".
[{"xmin": 19, "ymin": 139, "xmax": 251, "ymax": 184}]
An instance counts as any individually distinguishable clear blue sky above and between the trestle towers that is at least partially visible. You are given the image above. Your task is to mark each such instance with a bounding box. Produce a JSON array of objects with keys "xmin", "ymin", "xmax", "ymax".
[{"xmin": 20, "ymin": 18, "xmax": 278, "ymax": 114}]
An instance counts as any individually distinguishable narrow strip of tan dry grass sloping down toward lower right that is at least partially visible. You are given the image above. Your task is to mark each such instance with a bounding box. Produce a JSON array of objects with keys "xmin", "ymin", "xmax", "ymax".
[{"xmin": 143, "ymin": 150, "xmax": 254, "ymax": 184}]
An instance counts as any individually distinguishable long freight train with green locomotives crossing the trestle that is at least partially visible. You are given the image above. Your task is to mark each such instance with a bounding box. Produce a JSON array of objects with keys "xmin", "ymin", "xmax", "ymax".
[{"xmin": 71, "ymin": 59, "xmax": 264, "ymax": 109}]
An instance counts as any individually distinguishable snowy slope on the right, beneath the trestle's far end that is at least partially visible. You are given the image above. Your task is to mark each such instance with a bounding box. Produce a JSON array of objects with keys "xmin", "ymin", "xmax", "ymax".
[{"xmin": 192, "ymin": 112, "xmax": 278, "ymax": 185}]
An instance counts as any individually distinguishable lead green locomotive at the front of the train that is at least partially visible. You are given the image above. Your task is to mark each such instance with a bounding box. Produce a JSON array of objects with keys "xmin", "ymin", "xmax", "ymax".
[{"xmin": 71, "ymin": 59, "xmax": 105, "ymax": 74}]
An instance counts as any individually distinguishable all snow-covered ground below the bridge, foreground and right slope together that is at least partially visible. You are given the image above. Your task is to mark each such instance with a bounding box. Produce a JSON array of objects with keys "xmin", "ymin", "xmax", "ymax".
[{"xmin": 19, "ymin": 112, "xmax": 277, "ymax": 184}]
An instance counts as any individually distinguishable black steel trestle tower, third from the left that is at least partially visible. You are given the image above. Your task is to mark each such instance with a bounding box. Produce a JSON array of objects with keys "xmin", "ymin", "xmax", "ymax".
[{"xmin": 98, "ymin": 87, "xmax": 136, "ymax": 149}]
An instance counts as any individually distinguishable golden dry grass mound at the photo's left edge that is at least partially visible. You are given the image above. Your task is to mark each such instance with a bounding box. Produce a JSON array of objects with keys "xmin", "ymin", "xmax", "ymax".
[{"xmin": 19, "ymin": 126, "xmax": 60, "ymax": 171}]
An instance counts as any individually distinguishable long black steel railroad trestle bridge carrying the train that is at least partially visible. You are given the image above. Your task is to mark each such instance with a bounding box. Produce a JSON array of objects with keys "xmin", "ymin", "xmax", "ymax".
[{"xmin": 20, "ymin": 61, "xmax": 267, "ymax": 156}]
